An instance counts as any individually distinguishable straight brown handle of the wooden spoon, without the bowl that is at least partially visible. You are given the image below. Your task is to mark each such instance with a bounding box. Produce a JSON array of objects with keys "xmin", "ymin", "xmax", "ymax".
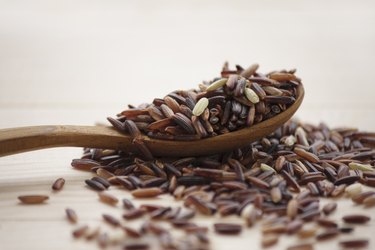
[{"xmin": 0, "ymin": 125, "xmax": 131, "ymax": 156}]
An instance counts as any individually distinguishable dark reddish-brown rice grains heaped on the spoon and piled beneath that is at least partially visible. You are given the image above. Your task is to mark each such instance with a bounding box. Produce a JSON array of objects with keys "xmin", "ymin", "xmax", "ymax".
[{"xmin": 20, "ymin": 64, "xmax": 375, "ymax": 250}]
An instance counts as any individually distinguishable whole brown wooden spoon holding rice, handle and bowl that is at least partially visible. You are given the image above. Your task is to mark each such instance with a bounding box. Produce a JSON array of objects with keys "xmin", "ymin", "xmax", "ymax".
[{"xmin": 0, "ymin": 85, "xmax": 304, "ymax": 156}]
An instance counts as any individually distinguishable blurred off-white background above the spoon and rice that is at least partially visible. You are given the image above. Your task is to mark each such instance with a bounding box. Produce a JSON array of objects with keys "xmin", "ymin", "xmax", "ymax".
[{"xmin": 0, "ymin": 0, "xmax": 375, "ymax": 130}]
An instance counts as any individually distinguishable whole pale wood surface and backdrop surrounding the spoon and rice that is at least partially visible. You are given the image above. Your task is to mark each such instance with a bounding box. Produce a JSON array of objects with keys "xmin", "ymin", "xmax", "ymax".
[{"xmin": 0, "ymin": 0, "xmax": 375, "ymax": 250}]
